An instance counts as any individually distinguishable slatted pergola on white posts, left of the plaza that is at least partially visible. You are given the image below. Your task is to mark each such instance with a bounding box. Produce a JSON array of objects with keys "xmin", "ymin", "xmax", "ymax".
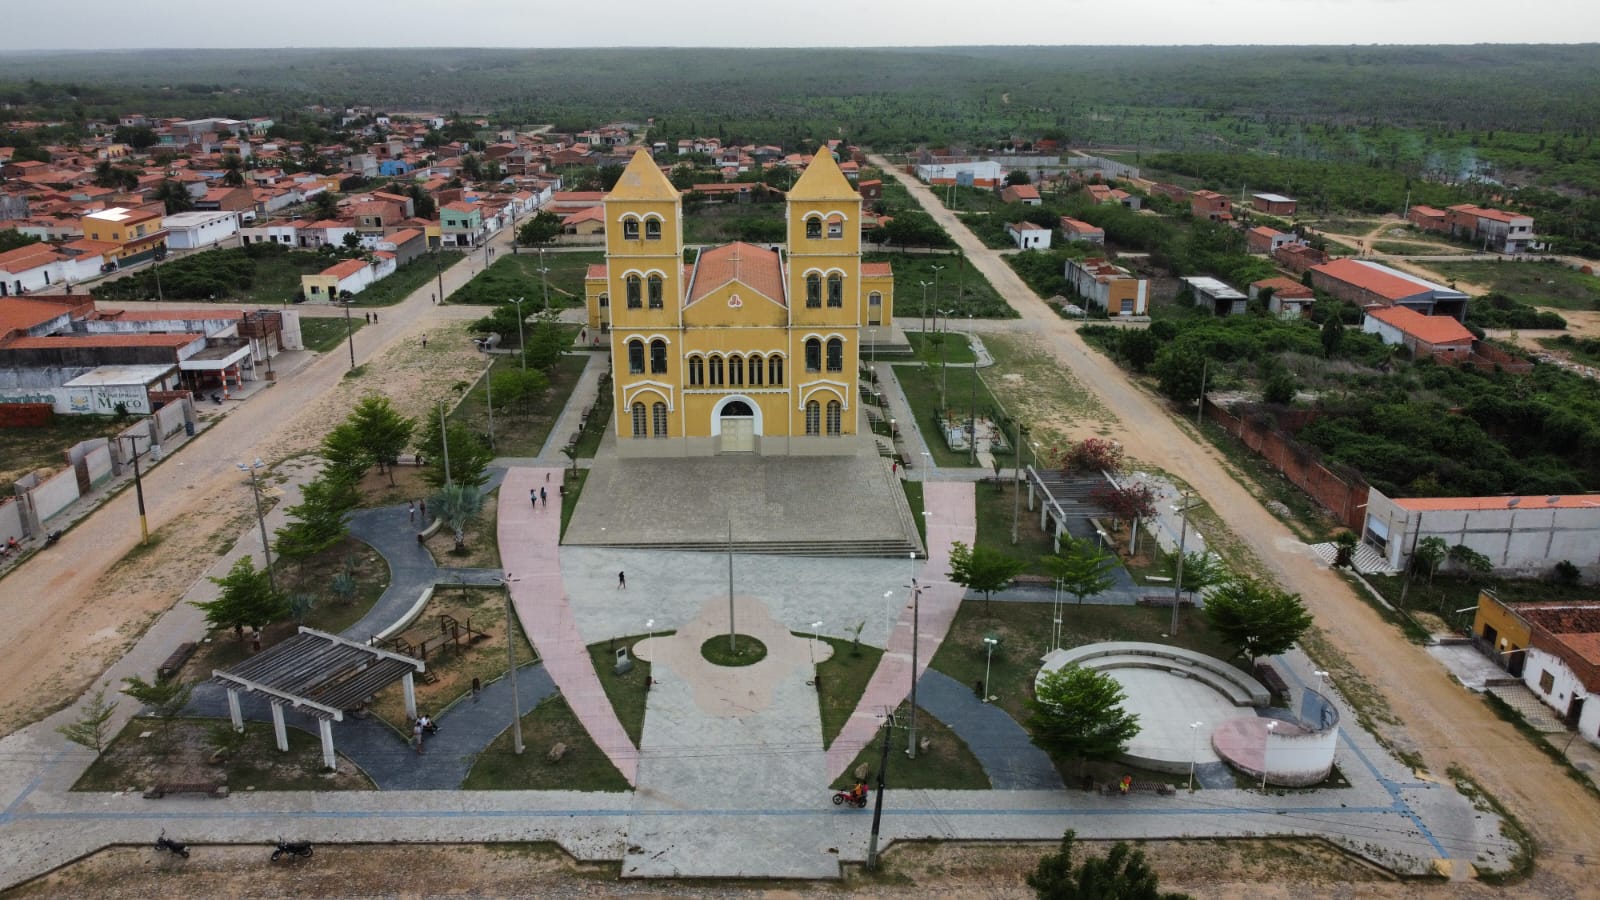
[{"xmin": 211, "ymin": 626, "xmax": 427, "ymax": 769}]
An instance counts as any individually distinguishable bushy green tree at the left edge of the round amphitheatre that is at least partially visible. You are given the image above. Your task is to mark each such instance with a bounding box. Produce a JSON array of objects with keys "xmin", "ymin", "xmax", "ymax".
[{"xmin": 1027, "ymin": 666, "xmax": 1139, "ymax": 770}]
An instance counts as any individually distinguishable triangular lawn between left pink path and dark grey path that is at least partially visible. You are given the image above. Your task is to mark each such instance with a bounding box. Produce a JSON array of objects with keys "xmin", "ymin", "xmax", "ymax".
[{"xmin": 461, "ymin": 695, "xmax": 630, "ymax": 791}]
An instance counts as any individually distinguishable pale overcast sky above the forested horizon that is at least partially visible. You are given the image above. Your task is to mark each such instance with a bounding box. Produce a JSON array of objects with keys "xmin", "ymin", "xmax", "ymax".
[{"xmin": 12, "ymin": 0, "xmax": 1600, "ymax": 50}]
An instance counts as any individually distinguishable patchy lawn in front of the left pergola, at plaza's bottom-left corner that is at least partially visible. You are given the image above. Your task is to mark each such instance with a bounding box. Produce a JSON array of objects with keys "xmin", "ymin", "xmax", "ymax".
[{"xmin": 72, "ymin": 714, "xmax": 373, "ymax": 793}]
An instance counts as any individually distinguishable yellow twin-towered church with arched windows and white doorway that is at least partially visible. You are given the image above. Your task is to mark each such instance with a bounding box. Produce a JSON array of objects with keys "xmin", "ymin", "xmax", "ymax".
[{"xmin": 584, "ymin": 149, "xmax": 894, "ymax": 456}]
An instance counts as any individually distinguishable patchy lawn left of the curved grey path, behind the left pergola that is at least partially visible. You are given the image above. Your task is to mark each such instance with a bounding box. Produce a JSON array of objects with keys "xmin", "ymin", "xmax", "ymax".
[{"xmin": 179, "ymin": 536, "xmax": 389, "ymax": 681}]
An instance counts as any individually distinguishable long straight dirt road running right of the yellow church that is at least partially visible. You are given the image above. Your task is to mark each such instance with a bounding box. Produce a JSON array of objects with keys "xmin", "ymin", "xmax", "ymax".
[{"xmin": 872, "ymin": 157, "xmax": 1600, "ymax": 892}]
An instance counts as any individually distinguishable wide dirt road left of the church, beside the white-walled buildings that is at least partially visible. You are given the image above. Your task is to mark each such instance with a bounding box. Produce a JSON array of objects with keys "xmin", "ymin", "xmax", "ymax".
[{"xmin": 0, "ymin": 227, "xmax": 504, "ymax": 733}]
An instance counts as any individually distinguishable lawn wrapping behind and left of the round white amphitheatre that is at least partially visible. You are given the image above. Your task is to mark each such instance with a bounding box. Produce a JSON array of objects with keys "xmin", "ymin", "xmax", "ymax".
[{"xmin": 933, "ymin": 597, "xmax": 1237, "ymax": 727}]
